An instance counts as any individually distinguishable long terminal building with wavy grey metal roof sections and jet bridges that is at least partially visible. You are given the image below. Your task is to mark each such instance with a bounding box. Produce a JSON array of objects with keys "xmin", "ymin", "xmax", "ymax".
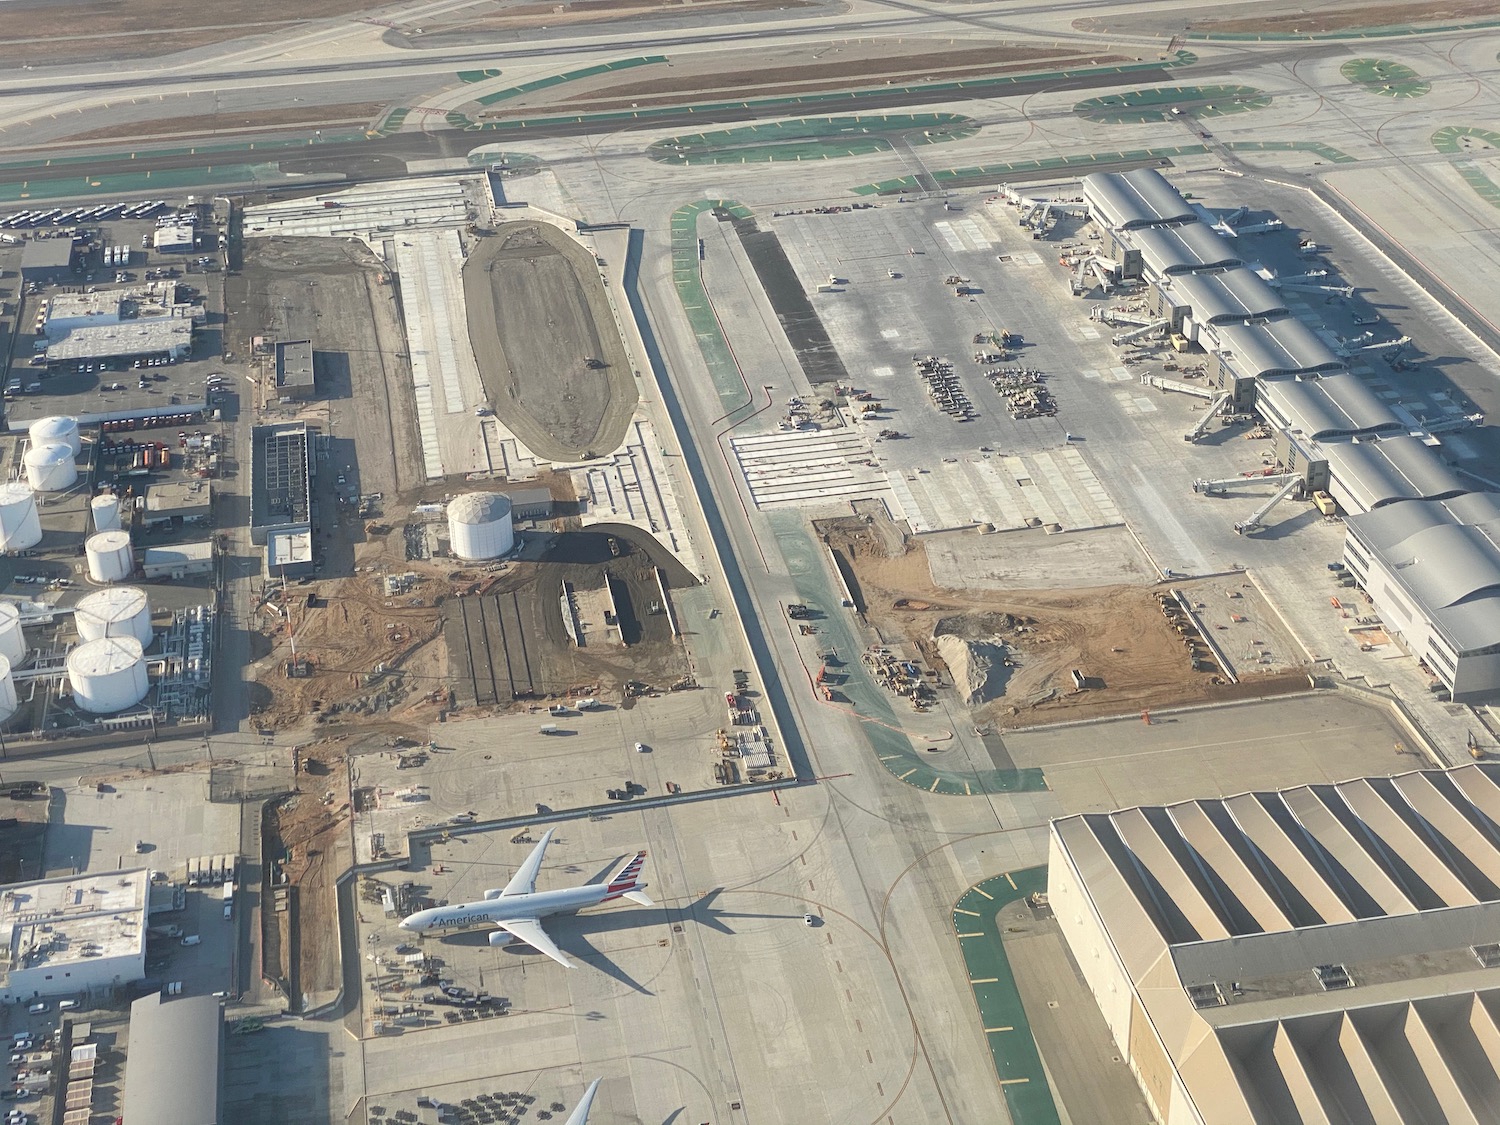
[{"xmin": 1076, "ymin": 168, "xmax": 1500, "ymax": 701}]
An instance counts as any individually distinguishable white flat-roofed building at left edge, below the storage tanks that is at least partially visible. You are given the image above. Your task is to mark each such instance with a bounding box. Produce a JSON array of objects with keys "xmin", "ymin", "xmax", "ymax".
[{"xmin": 0, "ymin": 867, "xmax": 150, "ymax": 1004}]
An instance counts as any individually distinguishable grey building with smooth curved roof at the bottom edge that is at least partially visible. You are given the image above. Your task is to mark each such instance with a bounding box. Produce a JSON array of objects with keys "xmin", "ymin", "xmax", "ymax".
[{"xmin": 122, "ymin": 993, "xmax": 224, "ymax": 1125}]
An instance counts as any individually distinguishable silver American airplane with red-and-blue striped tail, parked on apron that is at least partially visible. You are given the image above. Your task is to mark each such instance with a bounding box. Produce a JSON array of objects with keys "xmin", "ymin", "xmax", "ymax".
[{"xmin": 401, "ymin": 828, "xmax": 656, "ymax": 969}]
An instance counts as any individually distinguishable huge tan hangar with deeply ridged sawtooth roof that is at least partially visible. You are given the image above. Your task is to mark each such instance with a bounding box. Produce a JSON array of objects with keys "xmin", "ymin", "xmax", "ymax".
[{"xmin": 1047, "ymin": 768, "xmax": 1500, "ymax": 1125}]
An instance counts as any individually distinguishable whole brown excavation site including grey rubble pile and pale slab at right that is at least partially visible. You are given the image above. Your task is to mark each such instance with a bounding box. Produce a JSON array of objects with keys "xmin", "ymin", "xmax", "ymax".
[{"xmin": 816, "ymin": 519, "xmax": 1307, "ymax": 728}]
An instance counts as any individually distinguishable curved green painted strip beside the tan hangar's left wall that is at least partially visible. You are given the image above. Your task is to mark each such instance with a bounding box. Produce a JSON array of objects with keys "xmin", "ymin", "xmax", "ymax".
[{"xmin": 953, "ymin": 867, "xmax": 1061, "ymax": 1125}]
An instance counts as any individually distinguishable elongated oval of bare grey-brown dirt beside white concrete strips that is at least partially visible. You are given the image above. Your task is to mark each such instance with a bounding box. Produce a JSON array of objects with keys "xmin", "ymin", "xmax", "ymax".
[{"xmin": 464, "ymin": 222, "xmax": 638, "ymax": 461}]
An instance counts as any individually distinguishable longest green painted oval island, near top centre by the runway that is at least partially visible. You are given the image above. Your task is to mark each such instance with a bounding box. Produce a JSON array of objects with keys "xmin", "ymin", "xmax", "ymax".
[{"xmin": 647, "ymin": 113, "xmax": 980, "ymax": 165}]
